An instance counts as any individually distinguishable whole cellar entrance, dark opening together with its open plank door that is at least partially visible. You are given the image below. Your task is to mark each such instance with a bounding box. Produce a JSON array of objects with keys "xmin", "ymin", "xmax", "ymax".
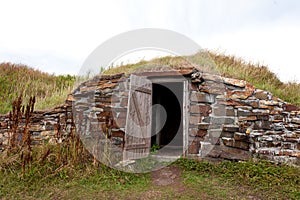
[{"xmin": 123, "ymin": 75, "xmax": 189, "ymax": 160}]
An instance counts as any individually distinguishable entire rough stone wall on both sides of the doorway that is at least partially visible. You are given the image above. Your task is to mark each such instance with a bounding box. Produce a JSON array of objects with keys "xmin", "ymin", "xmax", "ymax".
[{"xmin": 0, "ymin": 70, "xmax": 300, "ymax": 165}]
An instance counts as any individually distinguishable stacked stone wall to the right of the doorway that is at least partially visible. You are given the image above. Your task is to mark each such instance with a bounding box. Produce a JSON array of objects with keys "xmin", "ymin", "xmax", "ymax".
[{"xmin": 189, "ymin": 72, "xmax": 300, "ymax": 165}]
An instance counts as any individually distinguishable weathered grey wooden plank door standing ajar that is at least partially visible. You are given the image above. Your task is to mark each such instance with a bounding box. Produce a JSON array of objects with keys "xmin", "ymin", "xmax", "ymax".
[{"xmin": 123, "ymin": 75, "xmax": 152, "ymax": 160}]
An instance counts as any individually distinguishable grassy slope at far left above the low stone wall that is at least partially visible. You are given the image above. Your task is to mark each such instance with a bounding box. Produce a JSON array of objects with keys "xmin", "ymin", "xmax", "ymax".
[{"xmin": 0, "ymin": 63, "xmax": 75, "ymax": 113}]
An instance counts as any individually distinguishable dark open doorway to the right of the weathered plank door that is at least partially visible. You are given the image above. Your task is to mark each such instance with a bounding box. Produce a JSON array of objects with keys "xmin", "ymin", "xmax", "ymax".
[{"xmin": 151, "ymin": 81, "xmax": 184, "ymax": 156}]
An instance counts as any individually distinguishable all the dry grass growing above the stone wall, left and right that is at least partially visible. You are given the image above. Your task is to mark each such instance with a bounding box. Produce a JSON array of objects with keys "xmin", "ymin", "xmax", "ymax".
[{"xmin": 0, "ymin": 51, "xmax": 300, "ymax": 113}]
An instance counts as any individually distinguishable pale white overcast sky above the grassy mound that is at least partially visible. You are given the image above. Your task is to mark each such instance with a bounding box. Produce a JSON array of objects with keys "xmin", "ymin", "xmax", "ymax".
[{"xmin": 0, "ymin": 0, "xmax": 300, "ymax": 82}]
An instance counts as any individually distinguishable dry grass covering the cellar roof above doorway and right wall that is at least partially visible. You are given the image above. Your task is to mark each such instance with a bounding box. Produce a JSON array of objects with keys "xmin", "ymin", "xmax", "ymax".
[{"xmin": 103, "ymin": 51, "xmax": 300, "ymax": 106}]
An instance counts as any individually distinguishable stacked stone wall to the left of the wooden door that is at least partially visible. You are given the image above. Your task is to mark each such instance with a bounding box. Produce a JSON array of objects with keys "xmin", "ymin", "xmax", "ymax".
[{"xmin": 0, "ymin": 74, "xmax": 128, "ymax": 151}]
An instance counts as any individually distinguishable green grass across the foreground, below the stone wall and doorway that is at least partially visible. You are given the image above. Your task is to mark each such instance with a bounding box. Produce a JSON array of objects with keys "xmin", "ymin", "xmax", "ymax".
[{"xmin": 0, "ymin": 146, "xmax": 300, "ymax": 199}]
